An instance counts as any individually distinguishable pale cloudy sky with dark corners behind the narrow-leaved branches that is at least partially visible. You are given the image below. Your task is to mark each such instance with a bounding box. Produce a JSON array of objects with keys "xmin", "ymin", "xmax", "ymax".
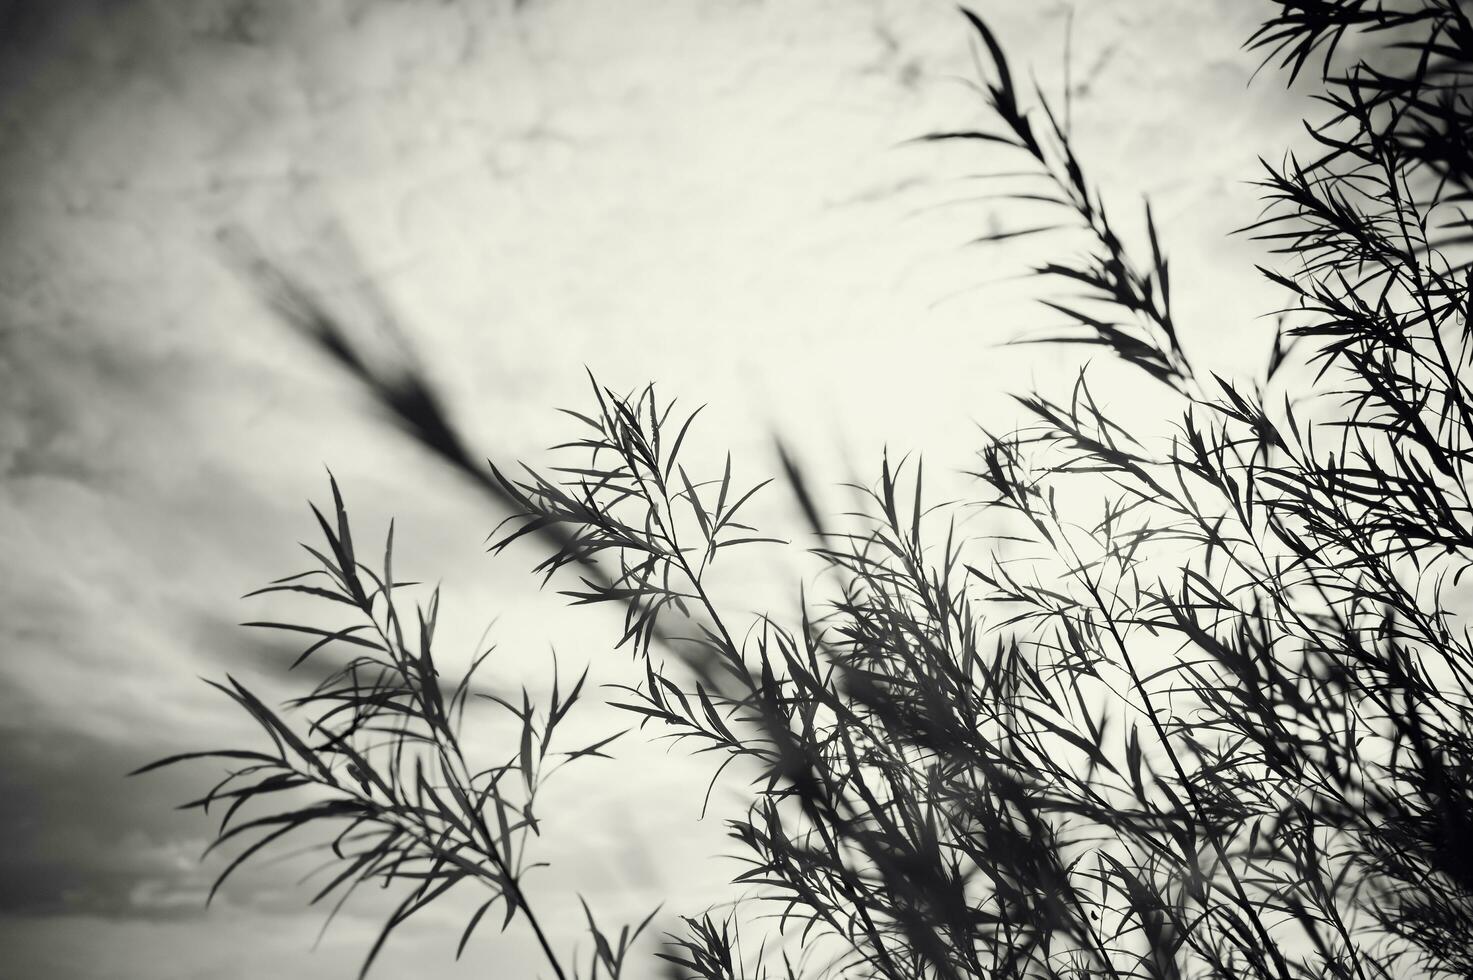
[{"xmin": 0, "ymin": 0, "xmax": 1302, "ymax": 980}]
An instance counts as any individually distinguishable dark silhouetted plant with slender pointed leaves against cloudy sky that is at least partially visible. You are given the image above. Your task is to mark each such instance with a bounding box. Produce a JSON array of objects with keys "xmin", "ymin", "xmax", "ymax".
[{"xmin": 143, "ymin": 0, "xmax": 1473, "ymax": 980}]
